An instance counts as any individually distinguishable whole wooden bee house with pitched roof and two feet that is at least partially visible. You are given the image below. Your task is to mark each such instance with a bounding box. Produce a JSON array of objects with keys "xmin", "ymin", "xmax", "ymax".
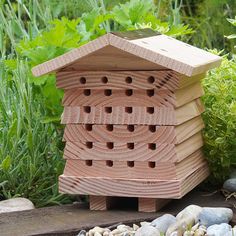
[{"xmin": 33, "ymin": 29, "xmax": 221, "ymax": 211}]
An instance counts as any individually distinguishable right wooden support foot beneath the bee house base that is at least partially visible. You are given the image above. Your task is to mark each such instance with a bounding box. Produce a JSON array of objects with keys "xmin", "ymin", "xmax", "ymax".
[{"xmin": 138, "ymin": 198, "xmax": 170, "ymax": 212}]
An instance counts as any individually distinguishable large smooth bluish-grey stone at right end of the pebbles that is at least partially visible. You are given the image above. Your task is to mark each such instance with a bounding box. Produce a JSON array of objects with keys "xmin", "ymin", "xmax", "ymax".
[{"xmin": 198, "ymin": 207, "xmax": 233, "ymax": 227}]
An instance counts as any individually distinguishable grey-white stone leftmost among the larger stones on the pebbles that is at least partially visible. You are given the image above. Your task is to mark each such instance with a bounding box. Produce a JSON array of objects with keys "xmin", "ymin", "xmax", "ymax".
[{"xmin": 151, "ymin": 214, "xmax": 176, "ymax": 233}]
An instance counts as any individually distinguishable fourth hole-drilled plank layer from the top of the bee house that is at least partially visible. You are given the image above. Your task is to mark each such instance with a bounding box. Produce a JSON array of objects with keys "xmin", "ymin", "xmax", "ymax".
[{"xmin": 63, "ymin": 116, "xmax": 204, "ymax": 144}]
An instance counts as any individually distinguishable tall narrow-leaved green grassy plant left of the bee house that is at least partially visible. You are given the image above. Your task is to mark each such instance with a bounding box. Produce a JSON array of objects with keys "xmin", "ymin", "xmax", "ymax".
[{"xmin": 0, "ymin": 61, "xmax": 69, "ymax": 206}]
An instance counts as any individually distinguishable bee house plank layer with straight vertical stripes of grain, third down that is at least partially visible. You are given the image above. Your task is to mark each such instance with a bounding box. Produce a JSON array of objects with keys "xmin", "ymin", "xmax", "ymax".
[{"xmin": 61, "ymin": 99, "xmax": 204, "ymax": 125}]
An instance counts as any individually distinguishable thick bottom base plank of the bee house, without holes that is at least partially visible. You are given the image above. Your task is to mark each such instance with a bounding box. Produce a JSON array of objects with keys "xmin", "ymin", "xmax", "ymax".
[{"xmin": 59, "ymin": 165, "xmax": 209, "ymax": 199}]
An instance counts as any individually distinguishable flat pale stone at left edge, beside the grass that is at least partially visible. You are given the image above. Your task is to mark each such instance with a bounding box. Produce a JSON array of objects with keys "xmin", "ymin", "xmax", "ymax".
[{"xmin": 0, "ymin": 197, "xmax": 35, "ymax": 213}]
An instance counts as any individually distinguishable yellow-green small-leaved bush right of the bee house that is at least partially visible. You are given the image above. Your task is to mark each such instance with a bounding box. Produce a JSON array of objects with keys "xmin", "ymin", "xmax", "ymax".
[{"xmin": 203, "ymin": 53, "xmax": 236, "ymax": 181}]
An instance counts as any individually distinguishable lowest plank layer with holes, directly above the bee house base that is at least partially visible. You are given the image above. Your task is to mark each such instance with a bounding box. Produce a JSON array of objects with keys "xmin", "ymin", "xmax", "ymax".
[{"xmin": 64, "ymin": 150, "xmax": 206, "ymax": 180}]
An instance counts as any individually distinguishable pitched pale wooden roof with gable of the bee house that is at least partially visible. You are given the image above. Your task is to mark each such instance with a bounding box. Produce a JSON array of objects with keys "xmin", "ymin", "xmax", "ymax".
[{"xmin": 32, "ymin": 29, "xmax": 221, "ymax": 76}]
